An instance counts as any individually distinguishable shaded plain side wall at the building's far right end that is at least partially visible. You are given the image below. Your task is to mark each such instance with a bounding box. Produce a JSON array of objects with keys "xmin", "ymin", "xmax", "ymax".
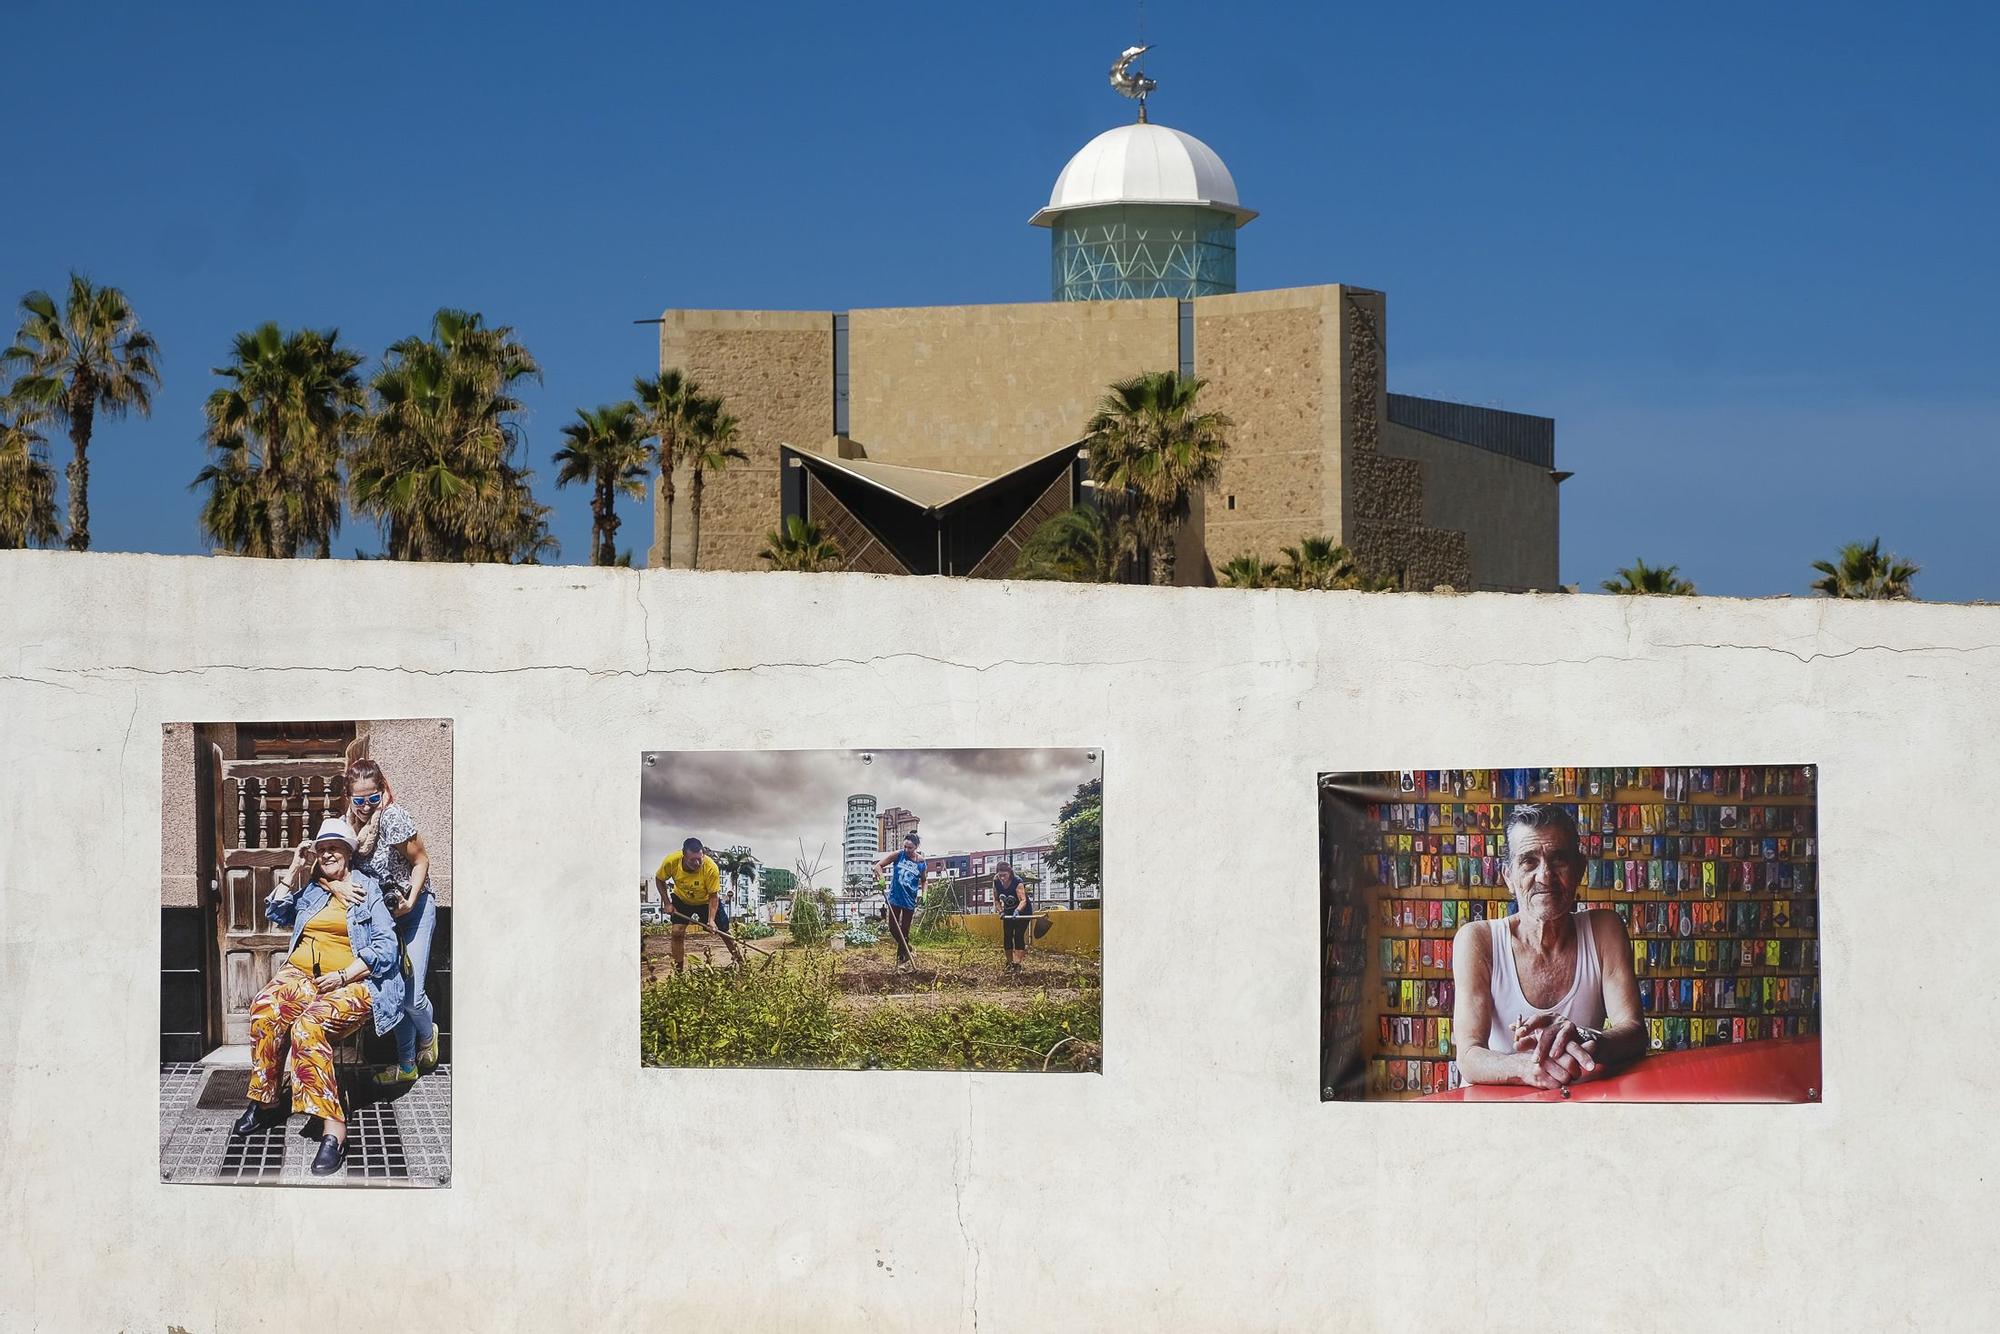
[{"xmin": 1382, "ymin": 422, "xmax": 1562, "ymax": 592}]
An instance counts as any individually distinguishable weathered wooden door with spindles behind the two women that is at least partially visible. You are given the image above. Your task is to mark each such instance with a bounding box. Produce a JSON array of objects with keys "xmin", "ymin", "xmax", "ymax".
[{"xmin": 208, "ymin": 746, "xmax": 344, "ymax": 1044}]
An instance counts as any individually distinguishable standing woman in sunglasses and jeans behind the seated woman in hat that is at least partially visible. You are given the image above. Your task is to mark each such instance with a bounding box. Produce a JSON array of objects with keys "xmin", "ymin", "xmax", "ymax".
[{"xmin": 346, "ymin": 758, "xmax": 438, "ymax": 1088}]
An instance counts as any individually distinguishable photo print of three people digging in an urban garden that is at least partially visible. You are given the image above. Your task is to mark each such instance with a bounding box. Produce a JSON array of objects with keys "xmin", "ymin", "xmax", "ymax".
[{"xmin": 638, "ymin": 748, "xmax": 1104, "ymax": 1072}]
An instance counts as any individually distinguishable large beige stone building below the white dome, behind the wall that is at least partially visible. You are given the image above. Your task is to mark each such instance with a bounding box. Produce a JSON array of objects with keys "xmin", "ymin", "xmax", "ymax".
[{"xmin": 650, "ymin": 284, "xmax": 1566, "ymax": 590}]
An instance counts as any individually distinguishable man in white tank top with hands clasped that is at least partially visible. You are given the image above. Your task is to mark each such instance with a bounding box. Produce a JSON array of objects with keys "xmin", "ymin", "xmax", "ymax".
[{"xmin": 1452, "ymin": 806, "xmax": 1646, "ymax": 1088}]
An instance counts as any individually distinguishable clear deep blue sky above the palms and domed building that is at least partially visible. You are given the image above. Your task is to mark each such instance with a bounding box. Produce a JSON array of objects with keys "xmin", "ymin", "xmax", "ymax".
[{"xmin": 0, "ymin": 0, "xmax": 2000, "ymax": 600}]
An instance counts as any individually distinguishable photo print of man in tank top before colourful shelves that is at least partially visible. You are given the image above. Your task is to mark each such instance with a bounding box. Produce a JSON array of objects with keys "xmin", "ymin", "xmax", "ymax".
[{"xmin": 1320, "ymin": 764, "xmax": 1824, "ymax": 1102}]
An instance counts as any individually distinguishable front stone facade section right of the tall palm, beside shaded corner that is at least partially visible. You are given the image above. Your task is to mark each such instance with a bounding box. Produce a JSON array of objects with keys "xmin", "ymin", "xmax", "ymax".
[{"xmin": 1194, "ymin": 286, "xmax": 1342, "ymax": 566}]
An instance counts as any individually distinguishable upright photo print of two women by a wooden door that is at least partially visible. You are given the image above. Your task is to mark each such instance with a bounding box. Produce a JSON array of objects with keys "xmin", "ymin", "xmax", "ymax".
[{"xmin": 160, "ymin": 718, "xmax": 452, "ymax": 1186}]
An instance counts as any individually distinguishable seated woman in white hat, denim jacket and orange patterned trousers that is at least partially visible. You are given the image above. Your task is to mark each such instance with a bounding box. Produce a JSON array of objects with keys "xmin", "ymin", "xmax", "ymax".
[{"xmin": 230, "ymin": 818, "xmax": 404, "ymax": 1176}]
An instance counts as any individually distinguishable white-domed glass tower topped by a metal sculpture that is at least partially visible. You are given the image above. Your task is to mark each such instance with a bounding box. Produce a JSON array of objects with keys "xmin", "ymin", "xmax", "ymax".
[{"xmin": 1028, "ymin": 46, "xmax": 1256, "ymax": 302}]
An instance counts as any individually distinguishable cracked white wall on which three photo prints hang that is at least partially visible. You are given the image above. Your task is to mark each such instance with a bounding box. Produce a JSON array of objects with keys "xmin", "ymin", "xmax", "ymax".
[{"xmin": 0, "ymin": 552, "xmax": 2000, "ymax": 1334}]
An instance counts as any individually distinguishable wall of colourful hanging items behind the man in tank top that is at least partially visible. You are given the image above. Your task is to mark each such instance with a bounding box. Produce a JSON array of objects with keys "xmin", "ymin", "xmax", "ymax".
[{"xmin": 1320, "ymin": 766, "xmax": 1820, "ymax": 1100}]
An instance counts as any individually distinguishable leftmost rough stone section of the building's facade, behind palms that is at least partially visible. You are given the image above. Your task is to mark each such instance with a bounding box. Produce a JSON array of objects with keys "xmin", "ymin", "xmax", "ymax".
[{"xmin": 648, "ymin": 310, "xmax": 834, "ymax": 570}]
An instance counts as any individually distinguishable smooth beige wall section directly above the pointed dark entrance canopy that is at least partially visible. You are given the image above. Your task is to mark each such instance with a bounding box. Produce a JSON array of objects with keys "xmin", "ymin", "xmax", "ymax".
[{"xmin": 840, "ymin": 300, "xmax": 1180, "ymax": 474}]
